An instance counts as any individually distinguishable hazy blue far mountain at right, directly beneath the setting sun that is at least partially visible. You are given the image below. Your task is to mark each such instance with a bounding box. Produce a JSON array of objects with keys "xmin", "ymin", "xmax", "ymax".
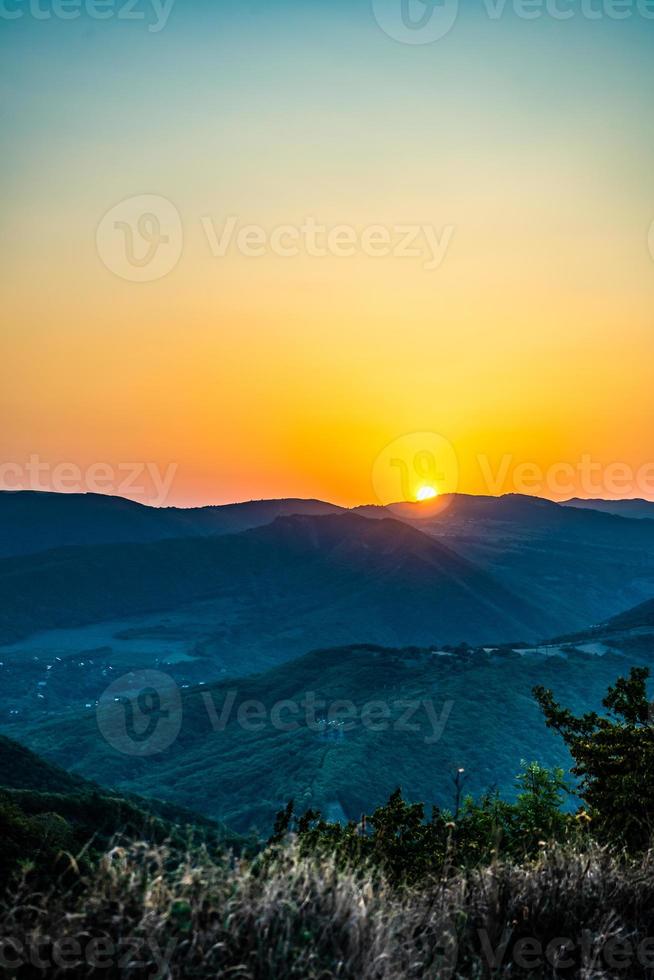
[{"xmin": 357, "ymin": 494, "xmax": 654, "ymax": 635}]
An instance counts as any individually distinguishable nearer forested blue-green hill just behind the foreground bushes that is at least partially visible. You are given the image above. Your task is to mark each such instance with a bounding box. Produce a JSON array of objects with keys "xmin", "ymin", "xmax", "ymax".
[{"xmin": 10, "ymin": 645, "xmax": 652, "ymax": 833}]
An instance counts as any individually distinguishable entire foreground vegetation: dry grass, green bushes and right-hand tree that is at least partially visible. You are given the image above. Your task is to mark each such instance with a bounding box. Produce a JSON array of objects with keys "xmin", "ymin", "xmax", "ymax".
[{"xmin": 0, "ymin": 668, "xmax": 654, "ymax": 980}]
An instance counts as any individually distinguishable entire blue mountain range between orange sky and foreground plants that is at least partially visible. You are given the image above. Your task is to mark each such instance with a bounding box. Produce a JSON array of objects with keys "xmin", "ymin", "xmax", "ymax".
[{"xmin": 0, "ymin": 492, "xmax": 654, "ymax": 832}]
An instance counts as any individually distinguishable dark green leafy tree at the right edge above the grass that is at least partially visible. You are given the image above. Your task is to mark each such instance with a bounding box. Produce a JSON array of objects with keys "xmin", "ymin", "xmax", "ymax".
[{"xmin": 534, "ymin": 667, "xmax": 654, "ymax": 849}]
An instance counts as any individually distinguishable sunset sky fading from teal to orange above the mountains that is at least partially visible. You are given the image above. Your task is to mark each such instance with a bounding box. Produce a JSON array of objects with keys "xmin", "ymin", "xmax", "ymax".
[{"xmin": 0, "ymin": 0, "xmax": 654, "ymax": 506}]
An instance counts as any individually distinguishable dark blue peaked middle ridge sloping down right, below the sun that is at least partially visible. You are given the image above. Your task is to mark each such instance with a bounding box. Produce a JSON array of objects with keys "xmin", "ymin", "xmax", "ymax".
[{"xmin": 0, "ymin": 514, "xmax": 547, "ymax": 661}]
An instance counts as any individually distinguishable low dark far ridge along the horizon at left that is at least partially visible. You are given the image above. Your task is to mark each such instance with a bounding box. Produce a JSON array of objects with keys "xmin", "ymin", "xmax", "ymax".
[{"xmin": 0, "ymin": 490, "xmax": 341, "ymax": 557}]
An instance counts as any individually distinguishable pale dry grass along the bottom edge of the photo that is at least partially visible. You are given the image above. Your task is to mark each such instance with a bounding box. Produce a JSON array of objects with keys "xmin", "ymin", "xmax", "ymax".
[{"xmin": 0, "ymin": 844, "xmax": 654, "ymax": 980}]
